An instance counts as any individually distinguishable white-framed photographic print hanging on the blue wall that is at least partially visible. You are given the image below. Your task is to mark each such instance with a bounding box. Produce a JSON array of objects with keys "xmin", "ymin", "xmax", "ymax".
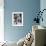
[{"xmin": 12, "ymin": 12, "xmax": 23, "ymax": 26}]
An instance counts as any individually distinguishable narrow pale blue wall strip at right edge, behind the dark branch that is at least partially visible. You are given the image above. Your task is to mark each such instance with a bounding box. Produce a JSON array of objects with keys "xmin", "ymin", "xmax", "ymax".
[{"xmin": 40, "ymin": 0, "xmax": 46, "ymax": 27}]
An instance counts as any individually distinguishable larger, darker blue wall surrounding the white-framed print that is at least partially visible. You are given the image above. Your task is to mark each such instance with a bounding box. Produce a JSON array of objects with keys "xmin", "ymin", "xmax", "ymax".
[{"xmin": 4, "ymin": 0, "xmax": 40, "ymax": 41}]
